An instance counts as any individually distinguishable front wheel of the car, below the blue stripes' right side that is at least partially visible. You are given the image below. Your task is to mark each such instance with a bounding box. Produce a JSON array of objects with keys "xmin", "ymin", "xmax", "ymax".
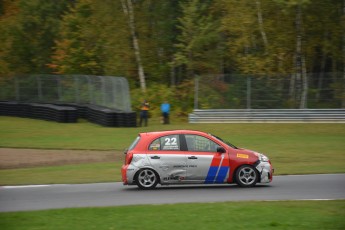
[{"xmin": 236, "ymin": 165, "xmax": 259, "ymax": 187}]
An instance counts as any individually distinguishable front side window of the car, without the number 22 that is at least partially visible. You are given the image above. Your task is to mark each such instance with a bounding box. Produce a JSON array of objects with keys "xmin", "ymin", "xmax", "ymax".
[{"xmin": 185, "ymin": 135, "xmax": 219, "ymax": 152}]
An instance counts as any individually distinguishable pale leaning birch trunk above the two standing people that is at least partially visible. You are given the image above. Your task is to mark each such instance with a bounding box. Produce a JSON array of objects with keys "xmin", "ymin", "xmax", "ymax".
[{"xmin": 121, "ymin": 0, "xmax": 146, "ymax": 93}]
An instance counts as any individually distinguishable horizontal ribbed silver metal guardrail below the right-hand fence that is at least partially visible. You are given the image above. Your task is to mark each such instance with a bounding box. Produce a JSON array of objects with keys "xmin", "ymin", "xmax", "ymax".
[{"xmin": 189, "ymin": 109, "xmax": 345, "ymax": 123}]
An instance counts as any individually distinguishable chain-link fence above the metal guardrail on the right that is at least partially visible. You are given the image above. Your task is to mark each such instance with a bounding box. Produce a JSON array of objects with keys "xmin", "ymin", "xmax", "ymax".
[{"xmin": 194, "ymin": 73, "xmax": 345, "ymax": 109}]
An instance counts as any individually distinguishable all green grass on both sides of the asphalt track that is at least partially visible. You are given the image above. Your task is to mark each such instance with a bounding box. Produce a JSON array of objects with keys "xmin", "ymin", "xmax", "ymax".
[{"xmin": 0, "ymin": 117, "xmax": 345, "ymax": 226}]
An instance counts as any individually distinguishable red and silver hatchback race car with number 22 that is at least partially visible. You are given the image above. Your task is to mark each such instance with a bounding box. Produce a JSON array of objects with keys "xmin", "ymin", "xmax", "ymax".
[{"xmin": 121, "ymin": 130, "xmax": 273, "ymax": 189}]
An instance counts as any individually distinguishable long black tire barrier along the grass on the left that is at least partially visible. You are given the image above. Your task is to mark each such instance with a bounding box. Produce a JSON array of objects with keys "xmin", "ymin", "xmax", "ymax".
[{"xmin": 0, "ymin": 101, "xmax": 137, "ymax": 127}]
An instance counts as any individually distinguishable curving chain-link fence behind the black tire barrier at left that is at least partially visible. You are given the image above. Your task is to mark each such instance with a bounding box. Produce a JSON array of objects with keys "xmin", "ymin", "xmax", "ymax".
[{"xmin": 0, "ymin": 75, "xmax": 131, "ymax": 112}]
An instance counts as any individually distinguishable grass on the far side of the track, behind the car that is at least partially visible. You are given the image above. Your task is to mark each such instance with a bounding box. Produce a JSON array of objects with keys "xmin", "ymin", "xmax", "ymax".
[{"xmin": 0, "ymin": 117, "xmax": 345, "ymax": 184}]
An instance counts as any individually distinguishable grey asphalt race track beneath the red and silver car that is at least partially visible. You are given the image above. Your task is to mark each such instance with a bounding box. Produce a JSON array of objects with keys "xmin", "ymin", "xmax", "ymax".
[{"xmin": 0, "ymin": 174, "xmax": 345, "ymax": 212}]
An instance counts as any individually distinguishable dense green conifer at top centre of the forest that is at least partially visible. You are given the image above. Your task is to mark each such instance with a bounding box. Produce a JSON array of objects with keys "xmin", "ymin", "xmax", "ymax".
[{"xmin": 174, "ymin": 0, "xmax": 222, "ymax": 78}]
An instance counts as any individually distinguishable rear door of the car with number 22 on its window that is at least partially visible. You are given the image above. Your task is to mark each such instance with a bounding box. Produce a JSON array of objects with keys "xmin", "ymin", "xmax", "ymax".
[{"xmin": 147, "ymin": 135, "xmax": 187, "ymax": 184}]
